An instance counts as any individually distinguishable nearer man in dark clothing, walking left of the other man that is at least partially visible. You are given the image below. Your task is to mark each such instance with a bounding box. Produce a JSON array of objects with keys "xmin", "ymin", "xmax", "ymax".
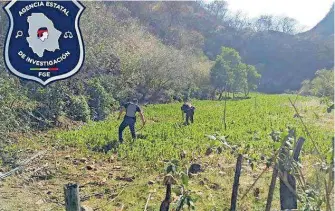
[{"xmin": 118, "ymin": 99, "xmax": 145, "ymax": 143}]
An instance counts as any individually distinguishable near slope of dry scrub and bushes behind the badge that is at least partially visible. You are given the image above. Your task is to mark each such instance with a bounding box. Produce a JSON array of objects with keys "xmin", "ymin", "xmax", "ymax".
[{"xmin": 0, "ymin": 2, "xmax": 215, "ymax": 137}]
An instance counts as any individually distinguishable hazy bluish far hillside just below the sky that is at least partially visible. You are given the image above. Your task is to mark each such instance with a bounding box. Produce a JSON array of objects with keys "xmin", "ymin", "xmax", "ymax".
[{"xmin": 125, "ymin": 2, "xmax": 334, "ymax": 93}]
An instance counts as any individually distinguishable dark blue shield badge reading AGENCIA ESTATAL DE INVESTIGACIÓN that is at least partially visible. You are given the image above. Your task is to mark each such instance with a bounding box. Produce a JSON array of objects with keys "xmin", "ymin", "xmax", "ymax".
[{"xmin": 4, "ymin": 0, "xmax": 85, "ymax": 86}]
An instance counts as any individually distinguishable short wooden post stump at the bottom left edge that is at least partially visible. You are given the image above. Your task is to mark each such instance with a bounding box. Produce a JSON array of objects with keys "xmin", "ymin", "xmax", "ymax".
[{"xmin": 64, "ymin": 183, "xmax": 80, "ymax": 211}]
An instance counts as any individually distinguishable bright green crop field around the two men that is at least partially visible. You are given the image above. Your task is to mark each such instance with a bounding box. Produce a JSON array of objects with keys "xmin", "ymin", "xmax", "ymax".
[{"xmin": 57, "ymin": 95, "xmax": 333, "ymax": 164}]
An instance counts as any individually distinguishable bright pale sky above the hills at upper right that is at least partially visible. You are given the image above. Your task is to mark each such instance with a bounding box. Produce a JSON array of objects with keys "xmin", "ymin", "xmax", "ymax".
[{"xmin": 207, "ymin": 0, "xmax": 334, "ymax": 30}]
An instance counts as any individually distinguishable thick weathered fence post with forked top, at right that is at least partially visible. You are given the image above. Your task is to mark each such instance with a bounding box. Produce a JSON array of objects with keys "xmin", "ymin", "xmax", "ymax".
[{"xmin": 279, "ymin": 137, "xmax": 305, "ymax": 210}]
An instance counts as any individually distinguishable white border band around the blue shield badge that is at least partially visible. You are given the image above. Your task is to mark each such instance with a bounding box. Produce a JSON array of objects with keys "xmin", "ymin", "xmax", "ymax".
[{"xmin": 5, "ymin": 0, "xmax": 85, "ymax": 86}]
